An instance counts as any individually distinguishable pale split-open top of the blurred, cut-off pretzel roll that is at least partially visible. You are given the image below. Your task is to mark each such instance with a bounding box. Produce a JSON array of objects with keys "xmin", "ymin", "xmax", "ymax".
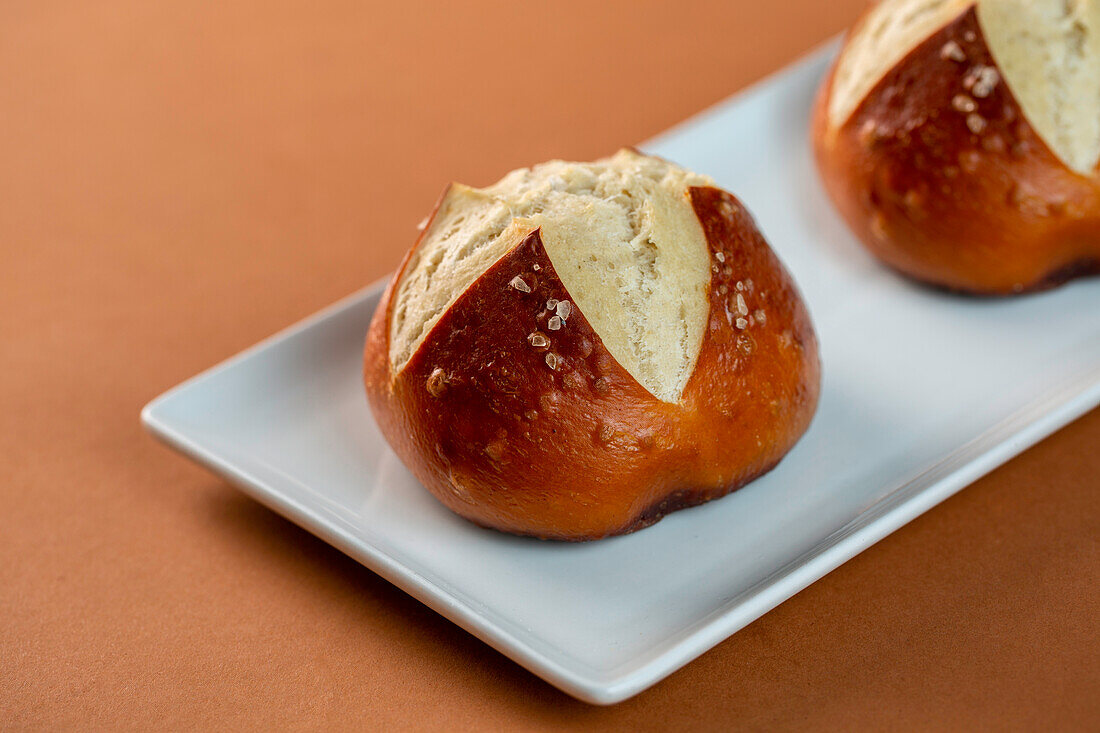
[{"xmin": 828, "ymin": 0, "xmax": 1100, "ymax": 176}]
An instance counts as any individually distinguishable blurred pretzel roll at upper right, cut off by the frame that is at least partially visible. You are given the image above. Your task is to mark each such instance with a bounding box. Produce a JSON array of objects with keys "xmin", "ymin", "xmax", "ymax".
[{"xmin": 813, "ymin": 0, "xmax": 1100, "ymax": 295}]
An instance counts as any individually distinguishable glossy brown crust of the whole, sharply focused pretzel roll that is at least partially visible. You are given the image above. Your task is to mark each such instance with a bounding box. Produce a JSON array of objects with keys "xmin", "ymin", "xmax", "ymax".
[{"xmin": 364, "ymin": 183, "xmax": 820, "ymax": 540}]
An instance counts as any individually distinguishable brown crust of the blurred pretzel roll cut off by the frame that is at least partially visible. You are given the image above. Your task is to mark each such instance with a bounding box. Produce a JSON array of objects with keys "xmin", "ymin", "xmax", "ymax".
[{"xmin": 813, "ymin": 7, "xmax": 1100, "ymax": 295}]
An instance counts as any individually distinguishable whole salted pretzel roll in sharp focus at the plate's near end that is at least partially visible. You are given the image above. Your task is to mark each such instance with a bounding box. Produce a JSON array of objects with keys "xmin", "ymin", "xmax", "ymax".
[{"xmin": 364, "ymin": 151, "xmax": 820, "ymax": 540}]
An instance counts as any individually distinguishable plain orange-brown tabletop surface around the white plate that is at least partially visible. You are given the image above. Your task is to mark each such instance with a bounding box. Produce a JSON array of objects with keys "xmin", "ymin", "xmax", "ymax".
[{"xmin": 0, "ymin": 0, "xmax": 1100, "ymax": 730}]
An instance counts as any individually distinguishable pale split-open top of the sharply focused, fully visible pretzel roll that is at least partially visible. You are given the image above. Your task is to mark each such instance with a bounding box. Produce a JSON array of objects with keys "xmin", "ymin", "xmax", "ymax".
[{"xmin": 389, "ymin": 150, "xmax": 714, "ymax": 402}]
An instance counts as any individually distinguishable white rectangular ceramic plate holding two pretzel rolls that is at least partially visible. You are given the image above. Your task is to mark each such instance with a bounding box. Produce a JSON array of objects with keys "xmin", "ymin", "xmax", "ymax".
[{"xmin": 143, "ymin": 44, "xmax": 1100, "ymax": 703}]
